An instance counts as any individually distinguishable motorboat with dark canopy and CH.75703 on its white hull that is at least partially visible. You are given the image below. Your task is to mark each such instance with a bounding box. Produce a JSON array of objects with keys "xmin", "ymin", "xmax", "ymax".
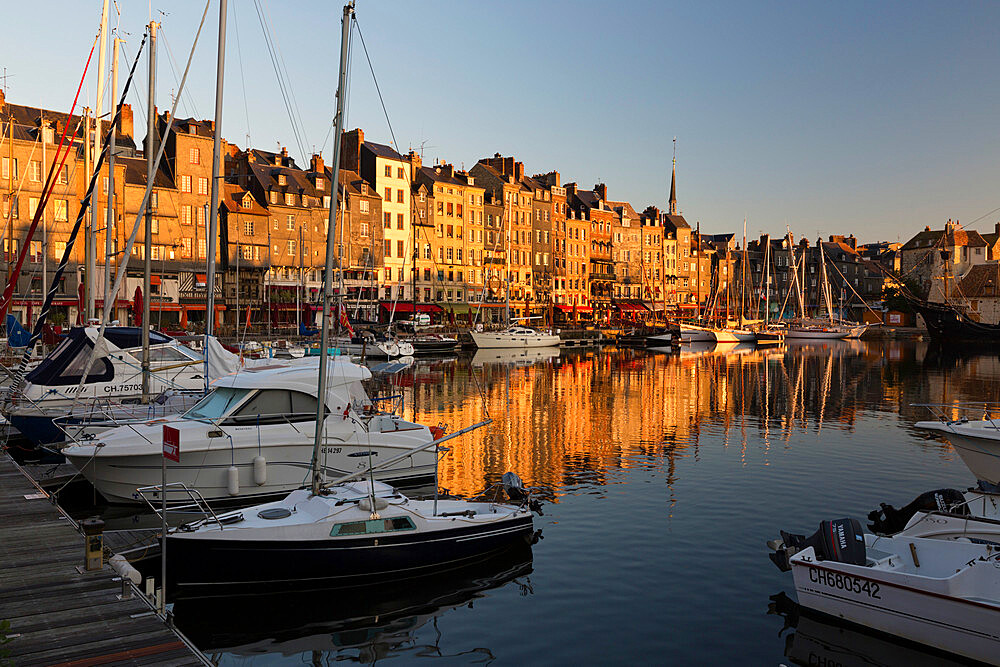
[{"xmin": 4, "ymin": 326, "xmax": 205, "ymax": 444}]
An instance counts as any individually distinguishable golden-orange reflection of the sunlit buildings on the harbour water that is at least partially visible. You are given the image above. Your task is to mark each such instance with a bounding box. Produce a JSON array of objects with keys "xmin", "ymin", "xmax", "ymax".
[{"xmin": 388, "ymin": 341, "xmax": 952, "ymax": 495}]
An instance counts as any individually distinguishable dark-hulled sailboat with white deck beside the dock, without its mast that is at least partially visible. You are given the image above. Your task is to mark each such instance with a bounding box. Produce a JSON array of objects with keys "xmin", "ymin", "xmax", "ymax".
[{"xmin": 166, "ymin": 473, "xmax": 537, "ymax": 598}]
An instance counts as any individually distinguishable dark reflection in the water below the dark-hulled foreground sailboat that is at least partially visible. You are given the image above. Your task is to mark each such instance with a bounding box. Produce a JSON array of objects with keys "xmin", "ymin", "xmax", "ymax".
[{"xmin": 174, "ymin": 545, "xmax": 532, "ymax": 664}]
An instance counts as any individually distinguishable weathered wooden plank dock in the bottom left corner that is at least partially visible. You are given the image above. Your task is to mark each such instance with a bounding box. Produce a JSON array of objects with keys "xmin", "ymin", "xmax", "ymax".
[{"xmin": 0, "ymin": 453, "xmax": 210, "ymax": 667}]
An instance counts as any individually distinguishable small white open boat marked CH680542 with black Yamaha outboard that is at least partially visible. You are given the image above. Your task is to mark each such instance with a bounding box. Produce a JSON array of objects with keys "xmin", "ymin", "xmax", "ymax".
[{"xmin": 769, "ymin": 519, "xmax": 1000, "ymax": 662}]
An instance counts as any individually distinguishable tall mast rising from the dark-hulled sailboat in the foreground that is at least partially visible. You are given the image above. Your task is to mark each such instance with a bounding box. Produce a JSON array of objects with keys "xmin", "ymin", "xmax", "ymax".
[{"xmin": 311, "ymin": 0, "xmax": 354, "ymax": 495}]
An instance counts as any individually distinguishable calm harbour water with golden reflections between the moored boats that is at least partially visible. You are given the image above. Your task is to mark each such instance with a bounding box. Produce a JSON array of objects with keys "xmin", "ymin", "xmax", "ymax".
[{"xmin": 166, "ymin": 341, "xmax": 1000, "ymax": 665}]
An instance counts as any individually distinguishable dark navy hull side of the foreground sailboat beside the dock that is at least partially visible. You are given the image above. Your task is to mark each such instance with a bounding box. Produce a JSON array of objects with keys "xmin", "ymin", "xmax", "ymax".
[{"xmin": 167, "ymin": 512, "xmax": 533, "ymax": 597}]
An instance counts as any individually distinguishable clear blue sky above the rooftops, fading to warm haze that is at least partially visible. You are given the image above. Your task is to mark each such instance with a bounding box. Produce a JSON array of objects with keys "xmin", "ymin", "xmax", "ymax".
[{"xmin": 0, "ymin": 0, "xmax": 1000, "ymax": 242}]
